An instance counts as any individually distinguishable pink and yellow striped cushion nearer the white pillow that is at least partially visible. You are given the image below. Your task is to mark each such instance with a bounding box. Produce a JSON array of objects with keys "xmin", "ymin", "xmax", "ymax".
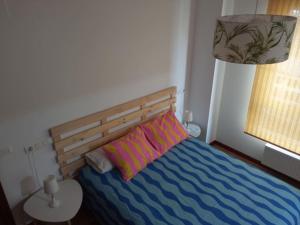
[{"xmin": 103, "ymin": 127, "xmax": 160, "ymax": 181}]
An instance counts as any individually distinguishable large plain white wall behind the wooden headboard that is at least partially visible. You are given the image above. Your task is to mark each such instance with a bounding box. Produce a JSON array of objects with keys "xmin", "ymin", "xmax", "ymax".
[{"xmin": 0, "ymin": 0, "xmax": 191, "ymax": 221}]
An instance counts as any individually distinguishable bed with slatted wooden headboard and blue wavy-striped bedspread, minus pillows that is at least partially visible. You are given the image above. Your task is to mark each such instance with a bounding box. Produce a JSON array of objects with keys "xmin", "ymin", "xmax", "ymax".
[{"xmin": 50, "ymin": 87, "xmax": 300, "ymax": 225}]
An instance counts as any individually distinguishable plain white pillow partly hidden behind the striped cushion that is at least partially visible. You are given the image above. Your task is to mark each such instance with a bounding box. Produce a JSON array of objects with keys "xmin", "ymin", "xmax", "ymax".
[{"xmin": 85, "ymin": 148, "xmax": 114, "ymax": 173}]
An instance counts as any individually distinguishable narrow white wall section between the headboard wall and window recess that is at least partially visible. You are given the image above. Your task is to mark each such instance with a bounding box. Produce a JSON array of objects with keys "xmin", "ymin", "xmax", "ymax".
[{"xmin": 188, "ymin": 0, "xmax": 222, "ymax": 139}]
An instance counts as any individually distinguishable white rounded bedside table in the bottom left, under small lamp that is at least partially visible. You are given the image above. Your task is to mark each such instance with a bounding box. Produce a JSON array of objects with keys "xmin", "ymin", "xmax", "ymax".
[{"xmin": 24, "ymin": 179, "xmax": 82, "ymax": 224}]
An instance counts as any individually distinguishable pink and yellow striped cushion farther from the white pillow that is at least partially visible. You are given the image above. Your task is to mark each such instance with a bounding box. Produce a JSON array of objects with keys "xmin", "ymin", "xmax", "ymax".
[{"xmin": 140, "ymin": 111, "xmax": 188, "ymax": 154}]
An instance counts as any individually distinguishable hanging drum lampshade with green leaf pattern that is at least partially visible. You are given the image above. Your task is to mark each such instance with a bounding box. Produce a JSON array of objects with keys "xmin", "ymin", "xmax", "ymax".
[{"xmin": 214, "ymin": 15, "xmax": 297, "ymax": 64}]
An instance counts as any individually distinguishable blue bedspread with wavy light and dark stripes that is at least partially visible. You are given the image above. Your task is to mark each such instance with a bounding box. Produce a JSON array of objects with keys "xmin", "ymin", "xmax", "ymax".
[{"xmin": 80, "ymin": 139, "xmax": 300, "ymax": 225}]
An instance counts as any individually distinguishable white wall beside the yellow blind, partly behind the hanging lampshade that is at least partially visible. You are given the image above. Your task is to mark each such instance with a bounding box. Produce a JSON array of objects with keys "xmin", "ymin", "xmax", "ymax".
[{"xmin": 210, "ymin": 0, "xmax": 267, "ymax": 160}]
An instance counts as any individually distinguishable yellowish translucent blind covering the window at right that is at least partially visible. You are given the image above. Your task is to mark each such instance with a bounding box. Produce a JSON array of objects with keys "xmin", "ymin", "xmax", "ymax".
[{"xmin": 245, "ymin": 0, "xmax": 300, "ymax": 154}]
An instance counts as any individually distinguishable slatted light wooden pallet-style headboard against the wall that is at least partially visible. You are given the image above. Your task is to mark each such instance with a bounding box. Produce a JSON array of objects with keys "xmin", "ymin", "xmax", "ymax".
[{"xmin": 50, "ymin": 87, "xmax": 176, "ymax": 178}]
